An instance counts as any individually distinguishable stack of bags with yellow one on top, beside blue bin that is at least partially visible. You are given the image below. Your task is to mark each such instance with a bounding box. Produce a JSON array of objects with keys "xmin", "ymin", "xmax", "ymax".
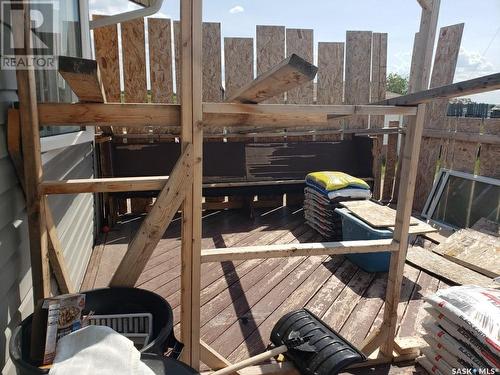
[{"xmin": 304, "ymin": 171, "xmax": 372, "ymax": 240}]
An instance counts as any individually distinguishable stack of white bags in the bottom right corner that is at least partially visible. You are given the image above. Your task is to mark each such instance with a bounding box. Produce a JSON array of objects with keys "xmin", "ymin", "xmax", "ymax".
[{"xmin": 417, "ymin": 286, "xmax": 500, "ymax": 375}]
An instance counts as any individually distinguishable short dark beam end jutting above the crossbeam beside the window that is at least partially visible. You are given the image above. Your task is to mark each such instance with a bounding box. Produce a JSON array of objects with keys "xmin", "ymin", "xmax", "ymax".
[{"xmin": 58, "ymin": 56, "xmax": 106, "ymax": 103}]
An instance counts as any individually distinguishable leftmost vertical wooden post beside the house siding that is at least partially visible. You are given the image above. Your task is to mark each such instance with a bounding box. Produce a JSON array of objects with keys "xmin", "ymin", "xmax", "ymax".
[{"xmin": 12, "ymin": 3, "xmax": 50, "ymax": 304}]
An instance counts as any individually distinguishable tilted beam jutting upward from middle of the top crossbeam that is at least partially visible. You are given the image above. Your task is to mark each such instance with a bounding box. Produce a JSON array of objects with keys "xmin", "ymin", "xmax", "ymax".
[{"xmin": 226, "ymin": 54, "xmax": 318, "ymax": 104}]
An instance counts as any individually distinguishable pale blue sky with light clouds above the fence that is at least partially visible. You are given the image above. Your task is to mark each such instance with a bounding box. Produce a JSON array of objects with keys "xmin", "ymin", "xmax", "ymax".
[{"xmin": 90, "ymin": 0, "xmax": 500, "ymax": 104}]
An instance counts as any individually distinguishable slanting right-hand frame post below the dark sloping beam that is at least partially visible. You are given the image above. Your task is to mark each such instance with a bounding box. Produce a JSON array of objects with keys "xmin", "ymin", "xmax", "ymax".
[{"xmin": 380, "ymin": 104, "xmax": 425, "ymax": 357}]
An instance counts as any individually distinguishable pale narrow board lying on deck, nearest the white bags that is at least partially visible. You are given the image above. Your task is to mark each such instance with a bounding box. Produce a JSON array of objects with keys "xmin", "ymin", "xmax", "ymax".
[{"xmin": 406, "ymin": 246, "xmax": 493, "ymax": 287}]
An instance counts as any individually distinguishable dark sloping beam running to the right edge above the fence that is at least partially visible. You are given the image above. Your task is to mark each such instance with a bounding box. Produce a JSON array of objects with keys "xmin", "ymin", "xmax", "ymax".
[{"xmin": 373, "ymin": 73, "xmax": 500, "ymax": 106}]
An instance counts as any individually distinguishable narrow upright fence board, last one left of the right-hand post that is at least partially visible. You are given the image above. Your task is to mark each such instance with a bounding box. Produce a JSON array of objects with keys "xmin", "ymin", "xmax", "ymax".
[{"xmin": 370, "ymin": 33, "xmax": 387, "ymax": 199}]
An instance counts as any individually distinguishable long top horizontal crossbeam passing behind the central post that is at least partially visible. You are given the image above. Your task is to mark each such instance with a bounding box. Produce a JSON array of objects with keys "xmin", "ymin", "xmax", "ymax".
[{"xmin": 38, "ymin": 103, "xmax": 416, "ymax": 134}]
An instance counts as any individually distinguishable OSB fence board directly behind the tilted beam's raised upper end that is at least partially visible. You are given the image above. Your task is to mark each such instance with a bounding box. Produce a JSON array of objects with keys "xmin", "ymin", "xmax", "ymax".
[{"xmin": 286, "ymin": 29, "xmax": 314, "ymax": 104}]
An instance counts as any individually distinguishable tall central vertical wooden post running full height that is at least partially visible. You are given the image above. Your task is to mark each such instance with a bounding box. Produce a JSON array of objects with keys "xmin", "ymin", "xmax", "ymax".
[{"xmin": 180, "ymin": 0, "xmax": 203, "ymax": 369}]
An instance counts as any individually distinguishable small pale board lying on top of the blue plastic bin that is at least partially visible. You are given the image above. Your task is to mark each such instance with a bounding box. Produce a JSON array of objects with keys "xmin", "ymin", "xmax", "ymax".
[{"xmin": 340, "ymin": 200, "xmax": 418, "ymax": 228}]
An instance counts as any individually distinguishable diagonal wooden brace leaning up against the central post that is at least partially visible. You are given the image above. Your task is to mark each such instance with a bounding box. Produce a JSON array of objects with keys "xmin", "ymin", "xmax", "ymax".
[{"xmin": 110, "ymin": 144, "xmax": 194, "ymax": 287}]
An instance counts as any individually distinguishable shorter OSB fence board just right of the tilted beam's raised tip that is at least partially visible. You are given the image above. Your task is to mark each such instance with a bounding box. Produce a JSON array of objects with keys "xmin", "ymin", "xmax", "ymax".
[{"xmin": 317, "ymin": 42, "xmax": 344, "ymax": 104}]
